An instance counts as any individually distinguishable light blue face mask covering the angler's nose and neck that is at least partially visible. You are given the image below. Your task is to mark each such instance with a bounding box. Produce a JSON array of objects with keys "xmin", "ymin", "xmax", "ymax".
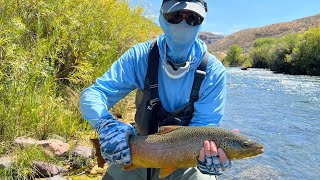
[{"xmin": 159, "ymin": 13, "xmax": 201, "ymax": 63}]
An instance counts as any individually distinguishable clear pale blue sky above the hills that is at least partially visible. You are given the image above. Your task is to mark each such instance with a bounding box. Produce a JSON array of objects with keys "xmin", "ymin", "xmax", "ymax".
[{"xmin": 130, "ymin": 0, "xmax": 320, "ymax": 35}]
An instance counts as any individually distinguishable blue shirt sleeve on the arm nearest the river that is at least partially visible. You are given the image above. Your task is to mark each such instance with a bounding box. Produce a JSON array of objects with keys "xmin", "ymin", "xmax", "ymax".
[{"xmin": 190, "ymin": 56, "xmax": 226, "ymax": 126}]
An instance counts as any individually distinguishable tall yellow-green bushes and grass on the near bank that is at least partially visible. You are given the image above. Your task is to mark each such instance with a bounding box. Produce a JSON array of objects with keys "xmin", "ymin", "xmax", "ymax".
[{"xmin": 0, "ymin": 0, "xmax": 161, "ymax": 179}]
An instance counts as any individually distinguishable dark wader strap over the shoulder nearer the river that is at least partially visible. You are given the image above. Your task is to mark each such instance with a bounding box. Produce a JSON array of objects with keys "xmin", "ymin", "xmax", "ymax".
[{"xmin": 189, "ymin": 52, "xmax": 209, "ymax": 103}]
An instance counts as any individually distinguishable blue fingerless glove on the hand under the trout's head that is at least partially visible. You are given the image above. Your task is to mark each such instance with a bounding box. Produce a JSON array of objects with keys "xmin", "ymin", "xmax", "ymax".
[{"xmin": 197, "ymin": 155, "xmax": 231, "ymax": 175}]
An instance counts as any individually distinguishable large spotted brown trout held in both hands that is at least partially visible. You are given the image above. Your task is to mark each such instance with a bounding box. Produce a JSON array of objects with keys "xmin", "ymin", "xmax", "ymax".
[{"xmin": 92, "ymin": 126, "xmax": 263, "ymax": 178}]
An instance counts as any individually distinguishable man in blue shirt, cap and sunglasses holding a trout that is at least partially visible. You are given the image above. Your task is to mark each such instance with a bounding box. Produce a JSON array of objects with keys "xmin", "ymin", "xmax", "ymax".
[{"xmin": 80, "ymin": 0, "xmax": 231, "ymax": 180}]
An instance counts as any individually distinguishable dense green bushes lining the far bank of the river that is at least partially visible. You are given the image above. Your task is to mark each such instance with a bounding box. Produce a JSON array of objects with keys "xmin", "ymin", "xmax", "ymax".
[{"xmin": 217, "ymin": 27, "xmax": 320, "ymax": 76}]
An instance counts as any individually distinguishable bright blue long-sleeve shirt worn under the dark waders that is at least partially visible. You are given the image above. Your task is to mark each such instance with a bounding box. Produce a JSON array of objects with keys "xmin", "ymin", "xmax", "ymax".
[{"xmin": 80, "ymin": 35, "xmax": 226, "ymax": 127}]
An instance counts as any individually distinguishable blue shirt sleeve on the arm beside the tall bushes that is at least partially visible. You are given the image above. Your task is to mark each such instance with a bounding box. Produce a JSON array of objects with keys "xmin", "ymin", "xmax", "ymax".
[{"xmin": 80, "ymin": 42, "xmax": 151, "ymax": 127}]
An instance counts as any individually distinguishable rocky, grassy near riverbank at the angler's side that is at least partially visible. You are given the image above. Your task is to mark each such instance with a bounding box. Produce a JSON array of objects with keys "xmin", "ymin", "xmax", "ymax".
[{"xmin": 0, "ymin": 92, "xmax": 135, "ymax": 180}]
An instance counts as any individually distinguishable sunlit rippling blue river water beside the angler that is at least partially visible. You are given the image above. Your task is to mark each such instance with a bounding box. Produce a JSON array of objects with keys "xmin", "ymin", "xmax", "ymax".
[{"xmin": 219, "ymin": 68, "xmax": 320, "ymax": 179}]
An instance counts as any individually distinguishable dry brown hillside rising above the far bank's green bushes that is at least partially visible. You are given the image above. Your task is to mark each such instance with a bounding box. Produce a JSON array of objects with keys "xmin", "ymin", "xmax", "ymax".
[{"xmin": 208, "ymin": 14, "xmax": 320, "ymax": 52}]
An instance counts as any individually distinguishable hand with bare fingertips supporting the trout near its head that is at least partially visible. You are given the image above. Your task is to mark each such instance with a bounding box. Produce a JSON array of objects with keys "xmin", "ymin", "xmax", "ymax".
[{"xmin": 198, "ymin": 141, "xmax": 231, "ymax": 175}]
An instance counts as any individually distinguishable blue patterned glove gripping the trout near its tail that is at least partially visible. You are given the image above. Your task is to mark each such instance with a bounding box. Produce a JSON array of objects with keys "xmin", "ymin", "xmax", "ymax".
[{"xmin": 96, "ymin": 118, "xmax": 137, "ymax": 165}]
